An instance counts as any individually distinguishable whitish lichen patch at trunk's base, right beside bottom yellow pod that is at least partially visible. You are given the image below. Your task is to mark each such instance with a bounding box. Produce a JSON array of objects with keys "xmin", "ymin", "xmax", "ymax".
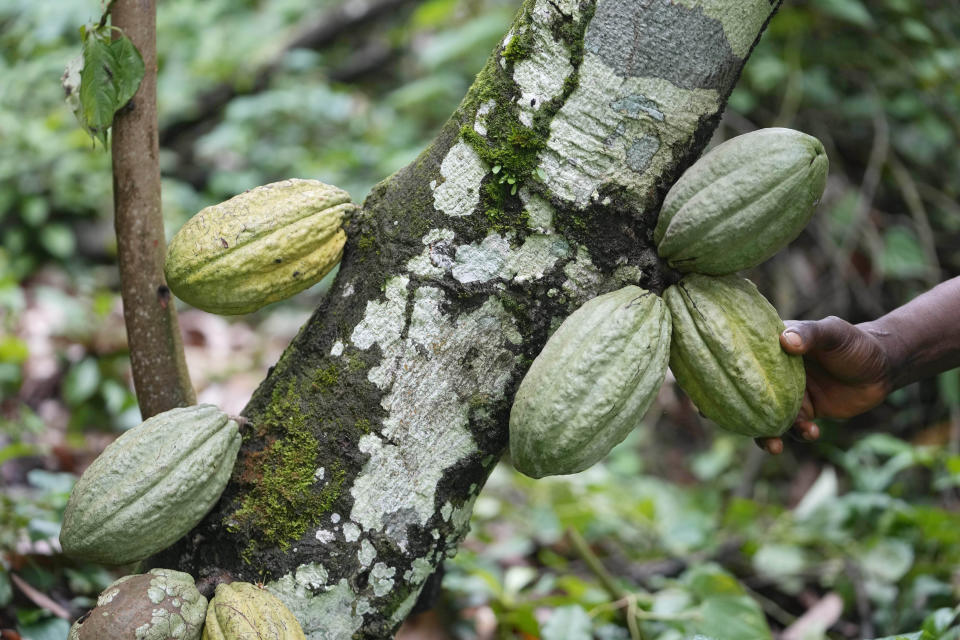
[{"xmin": 267, "ymin": 574, "xmax": 363, "ymax": 640}]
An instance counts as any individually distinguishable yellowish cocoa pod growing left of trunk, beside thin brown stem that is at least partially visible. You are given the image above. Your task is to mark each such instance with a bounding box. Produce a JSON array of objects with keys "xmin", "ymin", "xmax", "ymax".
[{"xmin": 164, "ymin": 180, "xmax": 356, "ymax": 315}]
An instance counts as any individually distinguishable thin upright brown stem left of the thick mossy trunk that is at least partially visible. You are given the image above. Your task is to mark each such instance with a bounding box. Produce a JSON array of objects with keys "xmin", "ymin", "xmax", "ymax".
[{"xmin": 111, "ymin": 0, "xmax": 196, "ymax": 419}]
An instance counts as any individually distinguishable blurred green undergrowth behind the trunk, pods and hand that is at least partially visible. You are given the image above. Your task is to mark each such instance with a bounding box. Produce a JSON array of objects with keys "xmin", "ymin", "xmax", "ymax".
[{"xmin": 0, "ymin": 0, "xmax": 960, "ymax": 640}]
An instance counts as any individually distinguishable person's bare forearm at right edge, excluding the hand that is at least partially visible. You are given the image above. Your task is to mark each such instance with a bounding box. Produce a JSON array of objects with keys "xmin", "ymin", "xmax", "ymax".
[{"xmin": 858, "ymin": 277, "xmax": 960, "ymax": 389}]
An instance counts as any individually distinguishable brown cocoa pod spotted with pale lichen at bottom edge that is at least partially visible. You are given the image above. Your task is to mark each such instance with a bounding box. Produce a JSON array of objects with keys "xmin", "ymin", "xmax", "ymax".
[{"xmin": 67, "ymin": 569, "xmax": 207, "ymax": 640}]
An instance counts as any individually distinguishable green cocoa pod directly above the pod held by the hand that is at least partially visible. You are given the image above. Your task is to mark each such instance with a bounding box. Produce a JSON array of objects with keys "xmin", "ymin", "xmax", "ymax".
[{"xmin": 653, "ymin": 128, "xmax": 828, "ymax": 275}]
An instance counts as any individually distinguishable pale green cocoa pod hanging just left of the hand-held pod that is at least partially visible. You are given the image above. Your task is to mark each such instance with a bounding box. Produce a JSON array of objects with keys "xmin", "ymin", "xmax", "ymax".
[{"xmin": 510, "ymin": 286, "xmax": 670, "ymax": 478}]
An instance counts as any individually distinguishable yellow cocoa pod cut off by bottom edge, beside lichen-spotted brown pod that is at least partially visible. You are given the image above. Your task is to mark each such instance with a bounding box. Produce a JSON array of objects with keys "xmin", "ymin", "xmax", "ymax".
[{"xmin": 203, "ymin": 582, "xmax": 306, "ymax": 640}]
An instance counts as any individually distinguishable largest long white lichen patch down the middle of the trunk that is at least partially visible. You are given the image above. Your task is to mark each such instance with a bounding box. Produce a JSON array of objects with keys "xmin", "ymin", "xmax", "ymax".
[{"xmin": 350, "ymin": 286, "xmax": 516, "ymax": 549}]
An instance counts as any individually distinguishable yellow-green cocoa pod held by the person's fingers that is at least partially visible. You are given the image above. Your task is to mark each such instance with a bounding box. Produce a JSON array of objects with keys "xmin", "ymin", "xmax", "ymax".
[{"xmin": 663, "ymin": 274, "xmax": 806, "ymax": 438}]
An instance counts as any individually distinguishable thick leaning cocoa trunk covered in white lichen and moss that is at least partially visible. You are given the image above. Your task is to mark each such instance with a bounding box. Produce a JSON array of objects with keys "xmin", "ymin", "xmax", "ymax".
[{"xmin": 151, "ymin": 0, "xmax": 779, "ymax": 639}]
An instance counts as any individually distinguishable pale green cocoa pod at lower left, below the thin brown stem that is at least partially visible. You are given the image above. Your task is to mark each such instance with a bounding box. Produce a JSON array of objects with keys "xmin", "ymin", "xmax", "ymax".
[{"xmin": 60, "ymin": 404, "xmax": 240, "ymax": 564}]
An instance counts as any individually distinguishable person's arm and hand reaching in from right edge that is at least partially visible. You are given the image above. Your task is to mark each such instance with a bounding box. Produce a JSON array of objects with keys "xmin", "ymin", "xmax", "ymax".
[{"xmin": 758, "ymin": 278, "xmax": 960, "ymax": 454}]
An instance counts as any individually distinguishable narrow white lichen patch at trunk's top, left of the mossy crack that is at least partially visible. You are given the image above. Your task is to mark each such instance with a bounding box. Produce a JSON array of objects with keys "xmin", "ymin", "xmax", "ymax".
[{"xmin": 513, "ymin": 0, "xmax": 573, "ymax": 127}]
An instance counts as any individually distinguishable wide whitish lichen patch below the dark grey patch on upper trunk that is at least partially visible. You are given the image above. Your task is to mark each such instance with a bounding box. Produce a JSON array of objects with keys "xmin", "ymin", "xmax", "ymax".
[{"xmin": 540, "ymin": 51, "xmax": 719, "ymax": 207}]
